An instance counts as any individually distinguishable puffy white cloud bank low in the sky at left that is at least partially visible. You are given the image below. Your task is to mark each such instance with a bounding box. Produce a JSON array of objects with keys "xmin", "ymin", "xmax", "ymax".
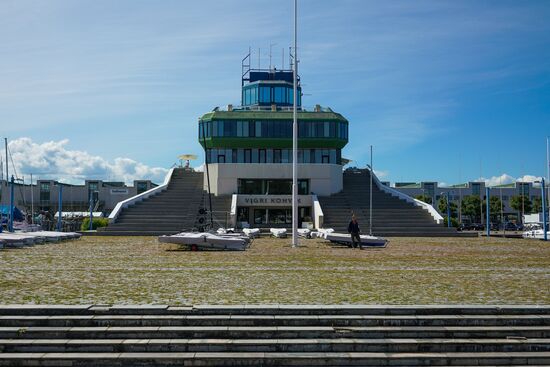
[{"xmin": 5, "ymin": 138, "xmax": 168, "ymax": 183}]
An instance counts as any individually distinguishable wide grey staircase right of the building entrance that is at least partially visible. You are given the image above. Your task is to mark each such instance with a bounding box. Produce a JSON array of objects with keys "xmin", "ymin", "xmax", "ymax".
[{"xmin": 319, "ymin": 169, "xmax": 477, "ymax": 237}]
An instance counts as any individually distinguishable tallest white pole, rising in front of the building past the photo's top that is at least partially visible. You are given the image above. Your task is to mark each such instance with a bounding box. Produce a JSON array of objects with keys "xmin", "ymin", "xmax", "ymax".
[{"xmin": 292, "ymin": 0, "xmax": 298, "ymax": 247}]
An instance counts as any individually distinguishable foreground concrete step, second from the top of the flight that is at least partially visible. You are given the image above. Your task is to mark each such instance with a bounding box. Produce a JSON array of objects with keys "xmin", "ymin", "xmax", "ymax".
[{"xmin": 0, "ymin": 315, "xmax": 550, "ymax": 327}]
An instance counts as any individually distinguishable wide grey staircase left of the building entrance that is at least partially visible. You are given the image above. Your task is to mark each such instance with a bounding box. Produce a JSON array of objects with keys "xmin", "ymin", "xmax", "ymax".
[{"xmin": 98, "ymin": 168, "xmax": 207, "ymax": 236}]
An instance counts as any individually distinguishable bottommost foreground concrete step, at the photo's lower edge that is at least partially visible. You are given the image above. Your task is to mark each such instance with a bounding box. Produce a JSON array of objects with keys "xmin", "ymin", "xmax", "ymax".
[{"xmin": 0, "ymin": 352, "xmax": 550, "ymax": 366}]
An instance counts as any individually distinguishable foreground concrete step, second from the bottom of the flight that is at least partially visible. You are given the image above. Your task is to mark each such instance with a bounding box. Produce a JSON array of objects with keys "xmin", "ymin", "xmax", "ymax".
[{"xmin": 0, "ymin": 338, "xmax": 550, "ymax": 355}]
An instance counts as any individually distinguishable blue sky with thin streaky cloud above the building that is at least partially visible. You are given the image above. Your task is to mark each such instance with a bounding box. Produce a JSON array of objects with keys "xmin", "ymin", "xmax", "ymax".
[{"xmin": 0, "ymin": 0, "xmax": 550, "ymax": 184}]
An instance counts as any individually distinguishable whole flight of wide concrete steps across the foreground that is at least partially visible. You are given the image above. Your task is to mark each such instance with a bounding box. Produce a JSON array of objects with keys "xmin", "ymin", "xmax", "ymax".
[{"xmin": 0, "ymin": 305, "xmax": 550, "ymax": 366}]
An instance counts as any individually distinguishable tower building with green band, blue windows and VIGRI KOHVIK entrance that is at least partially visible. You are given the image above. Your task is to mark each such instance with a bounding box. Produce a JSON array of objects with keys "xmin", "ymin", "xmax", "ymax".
[{"xmin": 198, "ymin": 64, "xmax": 348, "ymax": 226}]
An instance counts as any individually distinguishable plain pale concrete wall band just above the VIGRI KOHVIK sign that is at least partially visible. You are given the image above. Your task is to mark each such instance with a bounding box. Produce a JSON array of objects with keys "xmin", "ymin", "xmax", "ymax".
[{"xmin": 204, "ymin": 163, "xmax": 343, "ymax": 196}]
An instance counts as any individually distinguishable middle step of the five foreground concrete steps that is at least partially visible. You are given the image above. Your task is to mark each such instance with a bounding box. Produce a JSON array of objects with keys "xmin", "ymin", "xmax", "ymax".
[{"xmin": 0, "ymin": 326, "xmax": 550, "ymax": 339}]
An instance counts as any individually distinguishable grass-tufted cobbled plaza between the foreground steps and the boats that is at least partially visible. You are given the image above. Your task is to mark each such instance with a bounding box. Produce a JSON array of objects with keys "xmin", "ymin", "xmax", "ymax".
[{"xmin": 0, "ymin": 237, "xmax": 550, "ymax": 304}]
